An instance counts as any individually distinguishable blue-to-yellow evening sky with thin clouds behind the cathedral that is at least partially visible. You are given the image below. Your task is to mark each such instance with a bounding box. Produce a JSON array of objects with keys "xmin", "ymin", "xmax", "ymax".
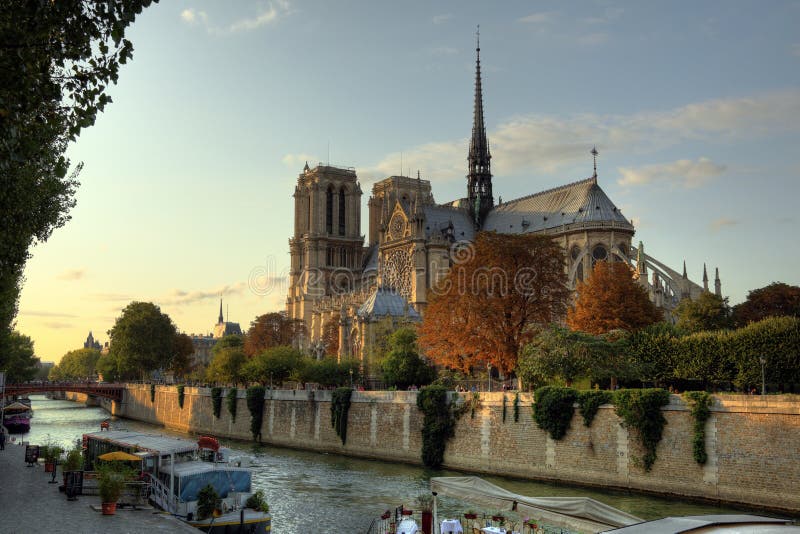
[{"xmin": 17, "ymin": 0, "xmax": 800, "ymax": 361}]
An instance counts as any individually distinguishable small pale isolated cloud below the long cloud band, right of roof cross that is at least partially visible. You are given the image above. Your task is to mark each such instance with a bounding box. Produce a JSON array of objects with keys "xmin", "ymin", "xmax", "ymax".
[{"xmin": 617, "ymin": 158, "xmax": 726, "ymax": 188}]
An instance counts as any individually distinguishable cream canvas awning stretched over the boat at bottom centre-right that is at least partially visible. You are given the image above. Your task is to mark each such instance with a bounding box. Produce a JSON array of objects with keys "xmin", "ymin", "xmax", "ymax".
[{"xmin": 431, "ymin": 476, "xmax": 644, "ymax": 532}]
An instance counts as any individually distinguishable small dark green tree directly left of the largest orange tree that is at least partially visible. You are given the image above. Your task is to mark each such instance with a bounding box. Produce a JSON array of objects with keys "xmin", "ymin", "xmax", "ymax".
[{"xmin": 381, "ymin": 327, "xmax": 436, "ymax": 389}]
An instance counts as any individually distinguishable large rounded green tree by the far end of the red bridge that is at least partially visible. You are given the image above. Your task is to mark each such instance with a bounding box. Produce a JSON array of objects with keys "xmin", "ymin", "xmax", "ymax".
[{"xmin": 108, "ymin": 302, "xmax": 177, "ymax": 379}]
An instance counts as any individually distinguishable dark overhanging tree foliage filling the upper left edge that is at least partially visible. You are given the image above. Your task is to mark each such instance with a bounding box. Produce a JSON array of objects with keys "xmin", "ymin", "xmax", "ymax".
[{"xmin": 0, "ymin": 0, "xmax": 158, "ymax": 368}]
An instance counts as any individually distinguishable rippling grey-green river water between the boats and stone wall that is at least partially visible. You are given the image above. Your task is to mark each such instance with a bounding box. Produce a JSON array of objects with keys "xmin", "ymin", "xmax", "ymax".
[{"xmin": 23, "ymin": 395, "xmax": 764, "ymax": 534}]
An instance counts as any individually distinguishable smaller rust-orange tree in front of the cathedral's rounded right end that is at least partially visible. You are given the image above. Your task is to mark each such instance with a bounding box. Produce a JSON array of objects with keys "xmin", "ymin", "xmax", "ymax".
[{"xmin": 567, "ymin": 261, "xmax": 663, "ymax": 335}]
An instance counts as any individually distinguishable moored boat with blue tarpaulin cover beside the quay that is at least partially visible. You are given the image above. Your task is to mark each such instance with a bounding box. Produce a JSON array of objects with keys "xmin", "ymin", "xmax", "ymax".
[{"xmin": 83, "ymin": 430, "xmax": 272, "ymax": 534}]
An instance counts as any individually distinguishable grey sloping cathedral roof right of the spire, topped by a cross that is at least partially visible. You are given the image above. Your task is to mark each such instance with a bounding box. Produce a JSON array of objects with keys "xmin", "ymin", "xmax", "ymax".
[{"xmin": 483, "ymin": 177, "xmax": 633, "ymax": 234}]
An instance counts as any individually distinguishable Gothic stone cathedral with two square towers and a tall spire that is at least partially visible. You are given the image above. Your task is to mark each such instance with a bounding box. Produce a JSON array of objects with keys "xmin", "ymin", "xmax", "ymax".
[{"xmin": 286, "ymin": 39, "xmax": 721, "ymax": 372}]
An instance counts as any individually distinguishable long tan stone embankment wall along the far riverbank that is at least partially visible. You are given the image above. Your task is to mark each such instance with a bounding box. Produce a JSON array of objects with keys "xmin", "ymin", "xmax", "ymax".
[{"xmin": 117, "ymin": 385, "xmax": 800, "ymax": 514}]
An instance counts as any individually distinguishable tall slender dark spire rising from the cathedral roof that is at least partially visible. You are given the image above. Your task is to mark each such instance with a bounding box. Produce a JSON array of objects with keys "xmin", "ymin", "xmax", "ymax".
[{"xmin": 467, "ymin": 26, "xmax": 494, "ymax": 228}]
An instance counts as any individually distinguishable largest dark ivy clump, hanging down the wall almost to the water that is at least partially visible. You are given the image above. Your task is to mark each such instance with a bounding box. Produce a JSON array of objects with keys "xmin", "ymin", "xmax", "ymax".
[{"xmin": 417, "ymin": 386, "xmax": 461, "ymax": 469}]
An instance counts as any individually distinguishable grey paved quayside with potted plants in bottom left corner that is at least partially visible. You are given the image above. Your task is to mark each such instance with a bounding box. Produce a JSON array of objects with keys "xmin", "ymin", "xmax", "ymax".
[{"xmin": 0, "ymin": 443, "xmax": 200, "ymax": 534}]
